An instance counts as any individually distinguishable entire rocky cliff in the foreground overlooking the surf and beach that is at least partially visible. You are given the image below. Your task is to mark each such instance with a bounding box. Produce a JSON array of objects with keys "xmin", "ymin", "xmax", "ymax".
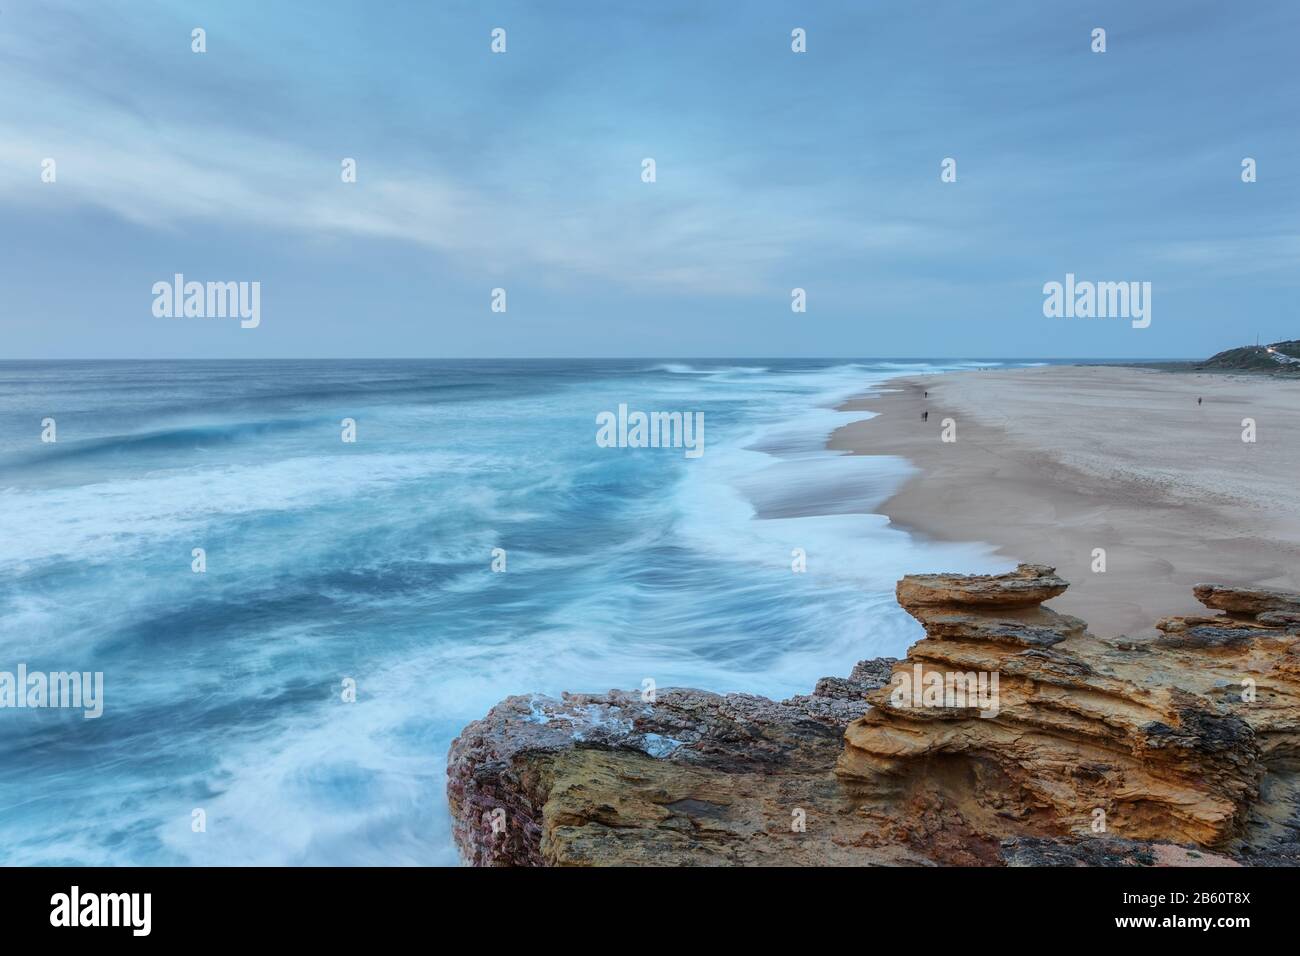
[{"xmin": 447, "ymin": 564, "xmax": 1300, "ymax": 865}]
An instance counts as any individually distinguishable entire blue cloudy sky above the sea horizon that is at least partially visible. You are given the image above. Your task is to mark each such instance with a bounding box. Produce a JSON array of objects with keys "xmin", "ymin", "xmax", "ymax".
[{"xmin": 0, "ymin": 0, "xmax": 1300, "ymax": 359}]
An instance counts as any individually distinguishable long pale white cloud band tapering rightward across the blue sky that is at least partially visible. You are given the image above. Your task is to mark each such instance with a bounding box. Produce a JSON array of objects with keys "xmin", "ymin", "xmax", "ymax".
[{"xmin": 0, "ymin": 58, "xmax": 946, "ymax": 294}]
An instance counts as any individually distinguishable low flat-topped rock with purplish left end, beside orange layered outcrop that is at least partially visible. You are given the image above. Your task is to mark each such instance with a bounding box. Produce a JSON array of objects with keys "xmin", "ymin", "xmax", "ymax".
[{"xmin": 447, "ymin": 661, "xmax": 910, "ymax": 866}]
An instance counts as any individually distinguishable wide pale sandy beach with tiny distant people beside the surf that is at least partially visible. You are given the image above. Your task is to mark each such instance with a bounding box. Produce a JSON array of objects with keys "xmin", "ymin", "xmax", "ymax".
[{"xmin": 829, "ymin": 365, "xmax": 1300, "ymax": 636}]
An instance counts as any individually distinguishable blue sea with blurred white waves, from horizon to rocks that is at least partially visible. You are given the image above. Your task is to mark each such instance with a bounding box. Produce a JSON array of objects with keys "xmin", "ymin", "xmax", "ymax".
[{"xmin": 0, "ymin": 360, "xmax": 1005, "ymax": 865}]
